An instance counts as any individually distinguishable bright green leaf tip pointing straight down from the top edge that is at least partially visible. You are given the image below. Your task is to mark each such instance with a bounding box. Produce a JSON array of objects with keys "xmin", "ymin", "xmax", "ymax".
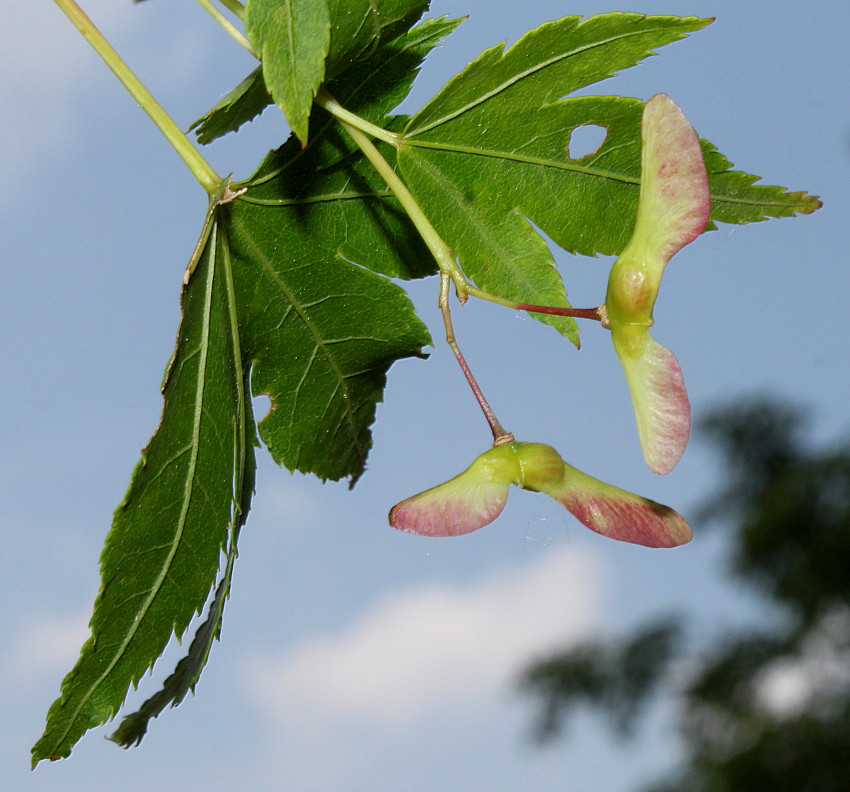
[{"xmin": 244, "ymin": 0, "xmax": 331, "ymax": 143}]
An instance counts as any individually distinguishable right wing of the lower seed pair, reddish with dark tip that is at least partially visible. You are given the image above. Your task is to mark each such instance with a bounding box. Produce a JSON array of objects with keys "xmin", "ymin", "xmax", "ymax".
[{"xmin": 548, "ymin": 465, "xmax": 693, "ymax": 547}]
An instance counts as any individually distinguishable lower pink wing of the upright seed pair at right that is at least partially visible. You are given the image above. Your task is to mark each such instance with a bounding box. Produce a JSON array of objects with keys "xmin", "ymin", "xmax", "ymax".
[{"xmin": 612, "ymin": 328, "xmax": 691, "ymax": 475}]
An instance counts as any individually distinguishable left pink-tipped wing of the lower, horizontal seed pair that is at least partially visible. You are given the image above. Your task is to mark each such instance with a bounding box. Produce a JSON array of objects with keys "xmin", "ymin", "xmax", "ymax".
[{"xmin": 390, "ymin": 466, "xmax": 508, "ymax": 536}]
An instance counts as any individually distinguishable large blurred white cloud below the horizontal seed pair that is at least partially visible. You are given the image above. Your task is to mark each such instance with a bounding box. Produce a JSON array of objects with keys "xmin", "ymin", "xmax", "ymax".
[{"xmin": 245, "ymin": 548, "xmax": 599, "ymax": 727}]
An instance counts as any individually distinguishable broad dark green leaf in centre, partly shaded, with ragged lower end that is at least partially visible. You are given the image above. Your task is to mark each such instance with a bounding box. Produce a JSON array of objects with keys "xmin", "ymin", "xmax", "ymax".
[{"xmin": 226, "ymin": 141, "xmax": 434, "ymax": 482}]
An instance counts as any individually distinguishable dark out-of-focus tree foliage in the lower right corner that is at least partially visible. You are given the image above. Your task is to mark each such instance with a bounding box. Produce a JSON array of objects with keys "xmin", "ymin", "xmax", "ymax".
[{"xmin": 520, "ymin": 400, "xmax": 850, "ymax": 792}]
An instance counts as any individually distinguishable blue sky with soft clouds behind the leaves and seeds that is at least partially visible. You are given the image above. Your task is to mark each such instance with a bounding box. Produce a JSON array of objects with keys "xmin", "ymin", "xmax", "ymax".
[{"xmin": 0, "ymin": 0, "xmax": 850, "ymax": 792}]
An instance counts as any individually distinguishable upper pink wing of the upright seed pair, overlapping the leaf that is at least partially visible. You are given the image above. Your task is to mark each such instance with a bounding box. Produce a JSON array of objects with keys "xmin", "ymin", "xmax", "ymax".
[{"xmin": 629, "ymin": 94, "xmax": 711, "ymax": 269}]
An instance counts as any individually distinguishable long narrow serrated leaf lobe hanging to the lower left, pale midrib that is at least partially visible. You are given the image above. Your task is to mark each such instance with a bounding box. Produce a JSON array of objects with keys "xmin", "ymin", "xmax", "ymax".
[{"xmin": 33, "ymin": 207, "xmax": 254, "ymax": 764}]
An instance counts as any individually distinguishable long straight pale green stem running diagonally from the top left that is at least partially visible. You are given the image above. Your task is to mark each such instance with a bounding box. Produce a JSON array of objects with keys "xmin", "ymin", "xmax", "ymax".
[{"xmin": 54, "ymin": 0, "xmax": 222, "ymax": 194}]
